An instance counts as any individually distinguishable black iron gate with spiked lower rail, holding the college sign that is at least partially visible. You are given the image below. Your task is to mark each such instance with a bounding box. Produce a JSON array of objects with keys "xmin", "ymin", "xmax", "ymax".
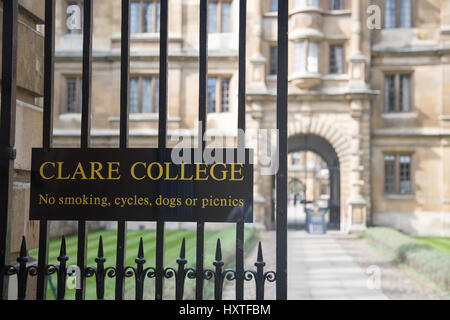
[{"xmin": 0, "ymin": 0, "xmax": 288, "ymax": 300}]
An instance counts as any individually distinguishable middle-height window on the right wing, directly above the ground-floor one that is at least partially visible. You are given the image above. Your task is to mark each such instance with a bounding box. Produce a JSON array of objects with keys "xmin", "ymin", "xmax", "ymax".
[{"xmin": 383, "ymin": 71, "xmax": 414, "ymax": 113}]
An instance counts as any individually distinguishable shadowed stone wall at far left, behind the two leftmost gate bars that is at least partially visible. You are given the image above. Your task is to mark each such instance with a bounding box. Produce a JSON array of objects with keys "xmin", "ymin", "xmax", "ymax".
[{"xmin": 0, "ymin": 0, "xmax": 44, "ymax": 297}]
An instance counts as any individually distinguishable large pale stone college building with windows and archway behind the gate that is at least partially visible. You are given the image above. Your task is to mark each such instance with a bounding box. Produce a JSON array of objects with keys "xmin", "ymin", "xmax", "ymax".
[{"xmin": 54, "ymin": 0, "xmax": 450, "ymax": 236}]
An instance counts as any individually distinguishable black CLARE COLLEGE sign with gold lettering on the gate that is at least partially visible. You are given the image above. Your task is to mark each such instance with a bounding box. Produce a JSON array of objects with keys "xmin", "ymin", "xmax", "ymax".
[{"xmin": 30, "ymin": 149, "xmax": 253, "ymax": 222}]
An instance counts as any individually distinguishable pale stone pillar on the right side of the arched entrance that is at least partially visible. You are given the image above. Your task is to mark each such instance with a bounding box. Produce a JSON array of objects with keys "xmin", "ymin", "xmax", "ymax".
[{"xmin": 345, "ymin": 100, "xmax": 367, "ymax": 233}]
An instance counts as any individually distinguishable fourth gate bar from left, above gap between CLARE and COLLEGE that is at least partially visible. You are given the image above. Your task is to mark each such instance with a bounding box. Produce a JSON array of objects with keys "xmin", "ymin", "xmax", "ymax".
[{"xmin": 115, "ymin": 0, "xmax": 130, "ymax": 300}]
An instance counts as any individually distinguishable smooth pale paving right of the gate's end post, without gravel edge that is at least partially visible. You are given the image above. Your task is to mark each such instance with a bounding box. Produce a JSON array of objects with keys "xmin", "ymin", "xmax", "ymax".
[{"xmin": 288, "ymin": 231, "xmax": 387, "ymax": 300}]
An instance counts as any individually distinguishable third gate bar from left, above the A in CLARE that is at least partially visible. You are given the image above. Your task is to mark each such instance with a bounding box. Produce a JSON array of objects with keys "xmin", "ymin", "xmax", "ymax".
[{"xmin": 75, "ymin": 0, "xmax": 93, "ymax": 300}]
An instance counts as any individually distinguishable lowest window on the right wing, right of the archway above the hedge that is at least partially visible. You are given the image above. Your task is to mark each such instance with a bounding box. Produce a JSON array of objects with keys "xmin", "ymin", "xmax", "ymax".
[{"xmin": 383, "ymin": 151, "xmax": 414, "ymax": 196}]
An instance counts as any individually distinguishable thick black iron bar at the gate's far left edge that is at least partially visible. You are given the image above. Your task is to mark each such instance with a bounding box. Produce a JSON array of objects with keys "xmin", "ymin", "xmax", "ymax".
[{"xmin": 0, "ymin": 1, "xmax": 18, "ymax": 300}]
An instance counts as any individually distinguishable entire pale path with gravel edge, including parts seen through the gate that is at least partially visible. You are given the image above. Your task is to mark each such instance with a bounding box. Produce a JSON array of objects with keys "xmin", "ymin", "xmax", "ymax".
[{"xmin": 224, "ymin": 230, "xmax": 444, "ymax": 300}]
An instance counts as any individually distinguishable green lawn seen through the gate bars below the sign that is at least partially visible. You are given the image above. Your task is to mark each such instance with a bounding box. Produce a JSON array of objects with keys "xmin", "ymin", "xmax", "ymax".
[{"xmin": 29, "ymin": 226, "xmax": 257, "ymax": 300}]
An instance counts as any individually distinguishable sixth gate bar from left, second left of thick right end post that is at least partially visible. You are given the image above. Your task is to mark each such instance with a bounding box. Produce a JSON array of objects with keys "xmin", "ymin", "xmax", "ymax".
[{"xmin": 195, "ymin": 0, "xmax": 208, "ymax": 300}]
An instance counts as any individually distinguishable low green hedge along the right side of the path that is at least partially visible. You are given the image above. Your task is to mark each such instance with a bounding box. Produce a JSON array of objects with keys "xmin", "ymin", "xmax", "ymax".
[{"xmin": 366, "ymin": 227, "xmax": 450, "ymax": 291}]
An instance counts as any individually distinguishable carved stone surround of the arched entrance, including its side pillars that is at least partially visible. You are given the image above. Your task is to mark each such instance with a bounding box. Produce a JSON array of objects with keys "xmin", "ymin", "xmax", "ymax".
[{"xmin": 250, "ymin": 96, "xmax": 371, "ymax": 233}]
